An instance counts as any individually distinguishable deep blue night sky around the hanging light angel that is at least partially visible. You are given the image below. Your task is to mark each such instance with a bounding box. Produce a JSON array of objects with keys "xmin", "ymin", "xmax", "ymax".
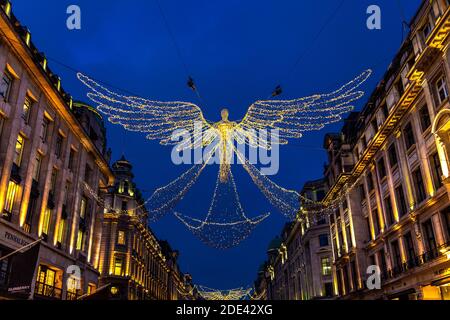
[{"xmin": 13, "ymin": 0, "xmax": 420, "ymax": 289}]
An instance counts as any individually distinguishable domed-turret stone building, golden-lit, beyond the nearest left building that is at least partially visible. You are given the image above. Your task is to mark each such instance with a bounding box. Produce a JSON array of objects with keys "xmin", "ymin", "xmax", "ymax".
[{"xmin": 99, "ymin": 157, "xmax": 197, "ymax": 300}]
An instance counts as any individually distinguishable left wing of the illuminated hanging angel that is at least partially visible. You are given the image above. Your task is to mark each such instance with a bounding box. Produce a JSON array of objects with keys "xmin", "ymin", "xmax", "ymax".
[{"xmin": 77, "ymin": 73, "xmax": 217, "ymax": 149}]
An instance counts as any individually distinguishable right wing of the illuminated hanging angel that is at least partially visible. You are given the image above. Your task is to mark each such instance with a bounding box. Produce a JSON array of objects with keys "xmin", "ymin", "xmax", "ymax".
[{"xmin": 235, "ymin": 70, "xmax": 372, "ymax": 148}]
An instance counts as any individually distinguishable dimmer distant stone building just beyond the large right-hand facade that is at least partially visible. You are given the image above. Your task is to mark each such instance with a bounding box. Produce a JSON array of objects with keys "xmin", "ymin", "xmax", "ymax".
[{"xmin": 255, "ymin": 180, "xmax": 333, "ymax": 300}]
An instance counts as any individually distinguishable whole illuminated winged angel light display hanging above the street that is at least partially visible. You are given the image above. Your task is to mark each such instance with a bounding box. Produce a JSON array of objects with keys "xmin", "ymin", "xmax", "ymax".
[{"xmin": 77, "ymin": 70, "xmax": 371, "ymax": 248}]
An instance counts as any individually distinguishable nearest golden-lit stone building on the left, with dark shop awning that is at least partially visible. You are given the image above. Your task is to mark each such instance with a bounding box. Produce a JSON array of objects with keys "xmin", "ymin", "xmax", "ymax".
[{"xmin": 0, "ymin": 1, "xmax": 114, "ymax": 299}]
